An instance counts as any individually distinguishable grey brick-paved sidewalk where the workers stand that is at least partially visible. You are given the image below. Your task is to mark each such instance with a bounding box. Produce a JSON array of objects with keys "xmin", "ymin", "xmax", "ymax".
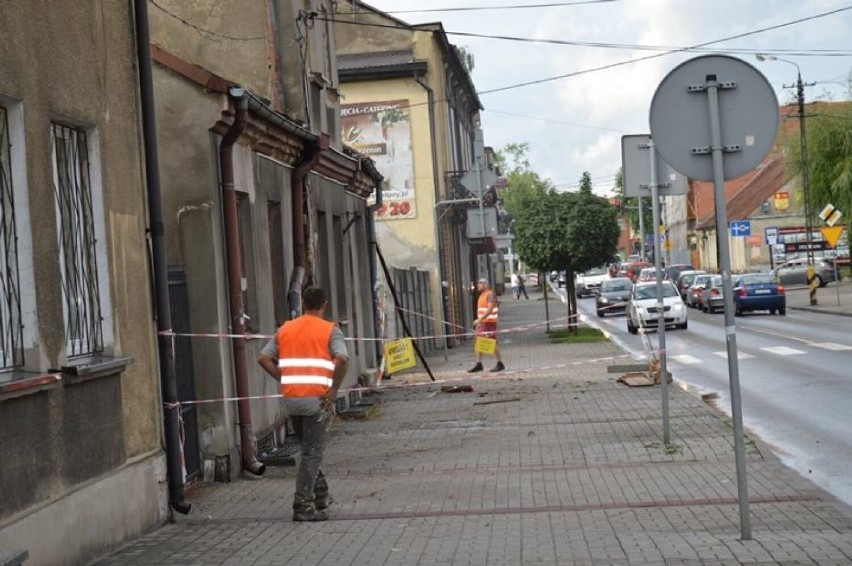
[{"xmin": 97, "ymin": 294, "xmax": 852, "ymax": 566}]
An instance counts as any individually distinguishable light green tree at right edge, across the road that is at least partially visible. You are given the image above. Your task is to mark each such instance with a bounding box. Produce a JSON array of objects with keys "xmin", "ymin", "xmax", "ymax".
[{"xmin": 787, "ymin": 102, "xmax": 852, "ymax": 251}]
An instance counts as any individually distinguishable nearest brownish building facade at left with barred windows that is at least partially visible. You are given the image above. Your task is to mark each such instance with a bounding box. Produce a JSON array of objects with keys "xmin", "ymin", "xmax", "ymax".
[{"xmin": 0, "ymin": 2, "xmax": 167, "ymax": 565}]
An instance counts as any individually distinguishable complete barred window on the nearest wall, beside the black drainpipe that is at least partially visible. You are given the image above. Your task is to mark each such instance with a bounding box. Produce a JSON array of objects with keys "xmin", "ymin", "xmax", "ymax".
[{"xmin": 51, "ymin": 124, "xmax": 104, "ymax": 357}]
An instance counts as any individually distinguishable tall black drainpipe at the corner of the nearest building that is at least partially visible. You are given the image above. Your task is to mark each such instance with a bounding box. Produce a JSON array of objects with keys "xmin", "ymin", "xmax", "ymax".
[{"xmin": 133, "ymin": 0, "xmax": 192, "ymax": 515}]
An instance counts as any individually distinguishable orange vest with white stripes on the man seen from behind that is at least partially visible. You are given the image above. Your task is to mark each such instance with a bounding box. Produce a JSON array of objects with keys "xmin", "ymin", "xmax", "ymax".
[{"xmin": 278, "ymin": 315, "xmax": 334, "ymax": 398}]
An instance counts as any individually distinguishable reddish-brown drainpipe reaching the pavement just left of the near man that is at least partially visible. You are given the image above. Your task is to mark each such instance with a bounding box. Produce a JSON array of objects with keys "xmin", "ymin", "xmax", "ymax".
[{"xmin": 219, "ymin": 87, "xmax": 266, "ymax": 476}]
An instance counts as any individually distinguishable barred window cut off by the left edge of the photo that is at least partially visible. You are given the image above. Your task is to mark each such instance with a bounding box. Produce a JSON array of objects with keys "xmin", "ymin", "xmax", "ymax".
[{"xmin": 0, "ymin": 106, "xmax": 24, "ymax": 370}]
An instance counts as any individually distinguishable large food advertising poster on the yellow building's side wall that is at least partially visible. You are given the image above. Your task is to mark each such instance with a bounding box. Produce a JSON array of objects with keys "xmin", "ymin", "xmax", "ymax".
[{"xmin": 340, "ymin": 100, "xmax": 417, "ymax": 220}]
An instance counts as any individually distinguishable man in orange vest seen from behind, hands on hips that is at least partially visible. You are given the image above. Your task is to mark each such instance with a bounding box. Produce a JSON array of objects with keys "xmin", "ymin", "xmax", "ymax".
[{"xmin": 257, "ymin": 287, "xmax": 349, "ymax": 521}]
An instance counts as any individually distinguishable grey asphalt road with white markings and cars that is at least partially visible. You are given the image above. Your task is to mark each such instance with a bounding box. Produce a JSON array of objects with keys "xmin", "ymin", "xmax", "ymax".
[{"xmin": 564, "ymin": 290, "xmax": 852, "ymax": 504}]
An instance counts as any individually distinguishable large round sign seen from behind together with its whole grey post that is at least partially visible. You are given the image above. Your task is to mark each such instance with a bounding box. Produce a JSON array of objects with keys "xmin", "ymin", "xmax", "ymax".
[{"xmin": 650, "ymin": 55, "xmax": 778, "ymax": 540}]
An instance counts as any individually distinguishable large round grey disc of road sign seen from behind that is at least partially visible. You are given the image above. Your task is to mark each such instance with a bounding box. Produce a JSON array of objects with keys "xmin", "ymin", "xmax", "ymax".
[{"xmin": 650, "ymin": 55, "xmax": 779, "ymax": 181}]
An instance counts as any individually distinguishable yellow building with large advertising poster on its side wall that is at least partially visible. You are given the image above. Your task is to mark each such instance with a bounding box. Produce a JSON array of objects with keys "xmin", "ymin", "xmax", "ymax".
[{"xmin": 335, "ymin": 0, "xmax": 492, "ymax": 347}]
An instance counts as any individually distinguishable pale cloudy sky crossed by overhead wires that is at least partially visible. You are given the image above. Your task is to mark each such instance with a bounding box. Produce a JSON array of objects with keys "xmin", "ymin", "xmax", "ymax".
[{"xmin": 367, "ymin": 0, "xmax": 852, "ymax": 195}]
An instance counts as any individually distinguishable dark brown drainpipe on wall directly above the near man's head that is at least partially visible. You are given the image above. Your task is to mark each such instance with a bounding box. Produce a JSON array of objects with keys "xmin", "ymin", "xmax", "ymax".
[{"xmin": 287, "ymin": 134, "xmax": 329, "ymax": 319}]
